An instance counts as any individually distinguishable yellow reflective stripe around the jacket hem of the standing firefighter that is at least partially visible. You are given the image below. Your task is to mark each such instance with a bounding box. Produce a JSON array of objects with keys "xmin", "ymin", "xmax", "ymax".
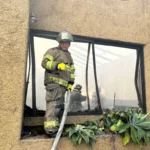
[{"xmin": 45, "ymin": 77, "xmax": 68, "ymax": 87}]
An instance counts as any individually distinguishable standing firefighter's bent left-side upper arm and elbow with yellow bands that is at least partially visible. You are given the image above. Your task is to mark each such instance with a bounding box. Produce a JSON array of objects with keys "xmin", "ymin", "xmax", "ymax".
[{"xmin": 41, "ymin": 49, "xmax": 58, "ymax": 70}]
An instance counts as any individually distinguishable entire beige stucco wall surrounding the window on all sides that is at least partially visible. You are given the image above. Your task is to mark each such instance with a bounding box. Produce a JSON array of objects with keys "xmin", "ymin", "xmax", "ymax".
[{"xmin": 0, "ymin": 0, "xmax": 150, "ymax": 150}]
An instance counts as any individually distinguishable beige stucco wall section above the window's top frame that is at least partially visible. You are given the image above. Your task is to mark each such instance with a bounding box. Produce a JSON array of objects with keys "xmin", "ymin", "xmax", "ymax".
[{"xmin": 31, "ymin": 0, "xmax": 150, "ymax": 44}]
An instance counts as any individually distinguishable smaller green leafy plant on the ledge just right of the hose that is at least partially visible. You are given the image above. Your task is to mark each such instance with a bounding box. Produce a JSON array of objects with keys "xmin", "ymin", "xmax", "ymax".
[{"xmin": 66, "ymin": 121, "xmax": 103, "ymax": 147}]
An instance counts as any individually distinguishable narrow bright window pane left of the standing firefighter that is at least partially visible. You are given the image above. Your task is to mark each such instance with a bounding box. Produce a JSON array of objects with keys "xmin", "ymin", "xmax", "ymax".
[{"xmin": 27, "ymin": 37, "xmax": 58, "ymax": 110}]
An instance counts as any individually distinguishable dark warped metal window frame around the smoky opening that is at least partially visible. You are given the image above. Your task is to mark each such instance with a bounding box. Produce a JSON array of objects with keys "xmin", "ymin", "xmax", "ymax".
[{"xmin": 25, "ymin": 29, "xmax": 146, "ymax": 116}]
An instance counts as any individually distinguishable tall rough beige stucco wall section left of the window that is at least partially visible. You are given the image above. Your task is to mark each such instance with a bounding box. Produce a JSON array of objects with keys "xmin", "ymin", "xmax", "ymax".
[{"xmin": 0, "ymin": 0, "xmax": 29, "ymax": 150}]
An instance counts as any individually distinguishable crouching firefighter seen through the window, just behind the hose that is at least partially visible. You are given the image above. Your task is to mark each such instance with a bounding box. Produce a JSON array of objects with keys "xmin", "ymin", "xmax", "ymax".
[{"xmin": 69, "ymin": 84, "xmax": 86, "ymax": 112}]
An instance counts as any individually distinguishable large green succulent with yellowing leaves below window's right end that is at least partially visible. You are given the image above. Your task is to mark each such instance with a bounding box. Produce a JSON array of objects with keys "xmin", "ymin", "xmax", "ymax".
[{"xmin": 100, "ymin": 108, "xmax": 150, "ymax": 148}]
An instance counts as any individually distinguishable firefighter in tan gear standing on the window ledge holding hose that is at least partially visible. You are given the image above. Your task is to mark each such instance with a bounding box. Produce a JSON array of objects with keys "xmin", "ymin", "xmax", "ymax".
[{"xmin": 41, "ymin": 30, "xmax": 75, "ymax": 136}]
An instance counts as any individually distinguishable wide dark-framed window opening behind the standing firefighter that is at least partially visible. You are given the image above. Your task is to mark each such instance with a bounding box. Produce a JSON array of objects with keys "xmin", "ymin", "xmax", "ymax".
[{"xmin": 23, "ymin": 30, "xmax": 146, "ymax": 139}]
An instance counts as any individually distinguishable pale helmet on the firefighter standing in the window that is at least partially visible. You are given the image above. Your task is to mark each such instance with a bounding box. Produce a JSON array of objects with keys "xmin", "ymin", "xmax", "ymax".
[{"xmin": 56, "ymin": 30, "xmax": 73, "ymax": 42}]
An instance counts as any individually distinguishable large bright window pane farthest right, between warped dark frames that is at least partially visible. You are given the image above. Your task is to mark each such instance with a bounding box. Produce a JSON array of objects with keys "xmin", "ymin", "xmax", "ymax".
[{"xmin": 95, "ymin": 45, "xmax": 138, "ymax": 108}]
